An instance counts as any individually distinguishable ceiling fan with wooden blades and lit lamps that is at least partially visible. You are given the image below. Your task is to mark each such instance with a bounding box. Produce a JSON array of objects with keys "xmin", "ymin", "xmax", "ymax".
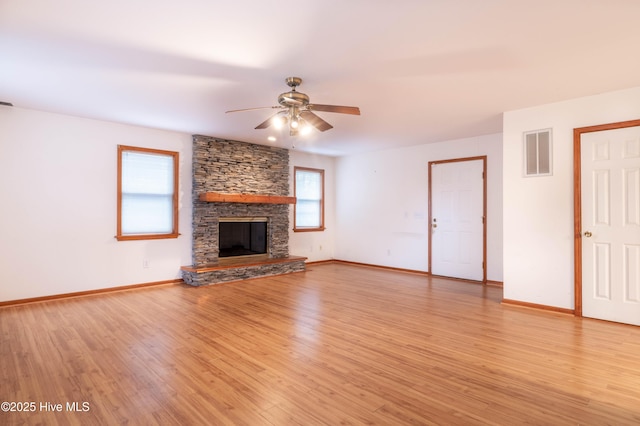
[{"xmin": 227, "ymin": 77, "xmax": 360, "ymax": 136}]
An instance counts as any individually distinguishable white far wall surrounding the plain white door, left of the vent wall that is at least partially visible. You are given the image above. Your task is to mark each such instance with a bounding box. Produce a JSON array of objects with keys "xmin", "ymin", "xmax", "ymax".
[{"xmin": 335, "ymin": 134, "xmax": 502, "ymax": 281}]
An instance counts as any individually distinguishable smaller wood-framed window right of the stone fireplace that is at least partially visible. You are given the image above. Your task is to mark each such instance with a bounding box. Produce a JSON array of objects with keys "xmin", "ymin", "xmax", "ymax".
[{"xmin": 293, "ymin": 167, "xmax": 324, "ymax": 231}]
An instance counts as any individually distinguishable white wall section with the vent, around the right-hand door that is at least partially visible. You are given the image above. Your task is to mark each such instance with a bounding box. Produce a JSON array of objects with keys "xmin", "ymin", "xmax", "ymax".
[{"xmin": 503, "ymin": 88, "xmax": 640, "ymax": 309}]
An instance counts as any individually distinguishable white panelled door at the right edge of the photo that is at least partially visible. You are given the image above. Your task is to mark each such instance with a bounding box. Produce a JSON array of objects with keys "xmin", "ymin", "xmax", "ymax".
[{"xmin": 580, "ymin": 127, "xmax": 640, "ymax": 325}]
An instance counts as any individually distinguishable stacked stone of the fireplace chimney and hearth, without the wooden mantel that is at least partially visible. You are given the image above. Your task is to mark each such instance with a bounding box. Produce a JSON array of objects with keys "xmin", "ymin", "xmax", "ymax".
[{"xmin": 183, "ymin": 135, "xmax": 305, "ymax": 285}]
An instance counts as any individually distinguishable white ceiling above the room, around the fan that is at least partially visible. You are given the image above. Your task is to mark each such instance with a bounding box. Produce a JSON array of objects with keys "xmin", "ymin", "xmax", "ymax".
[{"xmin": 0, "ymin": 0, "xmax": 640, "ymax": 155}]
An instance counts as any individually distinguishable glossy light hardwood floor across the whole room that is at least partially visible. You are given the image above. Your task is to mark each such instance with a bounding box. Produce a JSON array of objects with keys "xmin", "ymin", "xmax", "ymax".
[{"xmin": 0, "ymin": 263, "xmax": 640, "ymax": 425}]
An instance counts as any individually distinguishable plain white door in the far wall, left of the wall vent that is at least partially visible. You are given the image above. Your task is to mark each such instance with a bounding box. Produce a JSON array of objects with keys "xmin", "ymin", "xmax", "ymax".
[{"xmin": 430, "ymin": 160, "xmax": 484, "ymax": 281}]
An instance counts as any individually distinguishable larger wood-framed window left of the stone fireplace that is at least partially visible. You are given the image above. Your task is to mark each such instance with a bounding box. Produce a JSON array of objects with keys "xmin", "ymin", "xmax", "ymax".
[{"xmin": 116, "ymin": 145, "xmax": 178, "ymax": 241}]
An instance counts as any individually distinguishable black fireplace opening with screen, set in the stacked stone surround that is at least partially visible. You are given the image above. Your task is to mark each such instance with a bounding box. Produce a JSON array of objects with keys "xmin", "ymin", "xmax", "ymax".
[{"xmin": 218, "ymin": 218, "xmax": 267, "ymax": 257}]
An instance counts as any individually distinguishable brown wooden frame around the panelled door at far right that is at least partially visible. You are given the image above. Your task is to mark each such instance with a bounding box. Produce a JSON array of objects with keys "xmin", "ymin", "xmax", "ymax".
[{"xmin": 573, "ymin": 120, "xmax": 640, "ymax": 317}]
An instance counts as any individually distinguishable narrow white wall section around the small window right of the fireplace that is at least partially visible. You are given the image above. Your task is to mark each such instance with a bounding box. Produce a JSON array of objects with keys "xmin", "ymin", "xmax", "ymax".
[{"xmin": 289, "ymin": 149, "xmax": 337, "ymax": 262}]
